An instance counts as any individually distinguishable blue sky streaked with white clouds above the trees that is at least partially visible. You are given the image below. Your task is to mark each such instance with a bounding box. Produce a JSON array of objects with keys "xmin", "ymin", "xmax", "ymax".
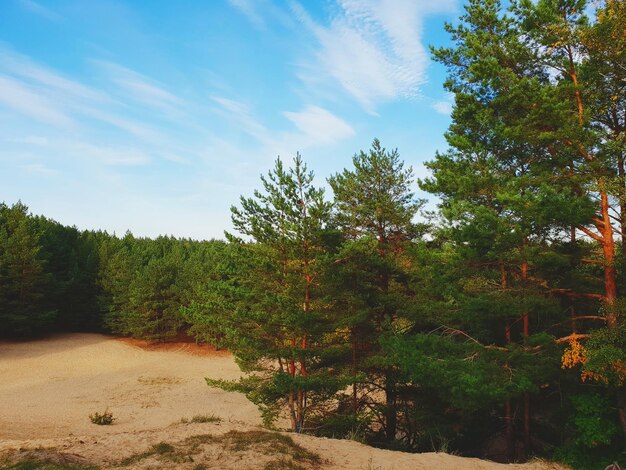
[{"xmin": 0, "ymin": 0, "xmax": 461, "ymax": 239}]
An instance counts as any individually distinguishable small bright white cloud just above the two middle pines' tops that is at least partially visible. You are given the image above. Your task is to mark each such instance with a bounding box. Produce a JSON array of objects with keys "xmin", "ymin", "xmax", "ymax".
[{"xmin": 283, "ymin": 106, "xmax": 355, "ymax": 144}]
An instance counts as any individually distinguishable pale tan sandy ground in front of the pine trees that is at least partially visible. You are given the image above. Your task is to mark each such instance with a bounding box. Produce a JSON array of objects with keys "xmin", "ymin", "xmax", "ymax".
[{"xmin": 0, "ymin": 334, "xmax": 562, "ymax": 470}]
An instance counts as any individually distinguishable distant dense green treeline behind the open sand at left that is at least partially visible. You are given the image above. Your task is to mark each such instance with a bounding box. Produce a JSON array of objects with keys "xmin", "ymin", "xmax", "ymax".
[{"xmin": 0, "ymin": 202, "xmax": 226, "ymax": 340}]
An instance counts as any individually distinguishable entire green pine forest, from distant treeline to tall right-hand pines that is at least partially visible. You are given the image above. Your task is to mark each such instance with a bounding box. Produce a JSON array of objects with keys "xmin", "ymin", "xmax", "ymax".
[{"xmin": 0, "ymin": 0, "xmax": 626, "ymax": 469}]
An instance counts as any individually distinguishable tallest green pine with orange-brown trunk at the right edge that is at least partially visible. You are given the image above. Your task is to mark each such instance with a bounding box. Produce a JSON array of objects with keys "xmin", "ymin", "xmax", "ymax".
[{"xmin": 426, "ymin": 0, "xmax": 626, "ymax": 452}]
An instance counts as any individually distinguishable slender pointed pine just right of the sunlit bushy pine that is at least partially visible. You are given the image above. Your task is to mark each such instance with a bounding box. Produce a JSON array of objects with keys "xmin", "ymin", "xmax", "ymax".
[{"xmin": 328, "ymin": 139, "xmax": 421, "ymax": 442}]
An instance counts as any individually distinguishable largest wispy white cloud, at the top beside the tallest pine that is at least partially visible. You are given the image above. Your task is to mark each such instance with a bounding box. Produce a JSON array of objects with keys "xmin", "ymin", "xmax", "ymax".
[{"xmin": 292, "ymin": 0, "xmax": 456, "ymax": 113}]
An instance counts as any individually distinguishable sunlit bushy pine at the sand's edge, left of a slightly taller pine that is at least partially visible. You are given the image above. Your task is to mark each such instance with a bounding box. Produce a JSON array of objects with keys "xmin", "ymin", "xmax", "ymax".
[{"xmin": 201, "ymin": 155, "xmax": 343, "ymax": 432}]
